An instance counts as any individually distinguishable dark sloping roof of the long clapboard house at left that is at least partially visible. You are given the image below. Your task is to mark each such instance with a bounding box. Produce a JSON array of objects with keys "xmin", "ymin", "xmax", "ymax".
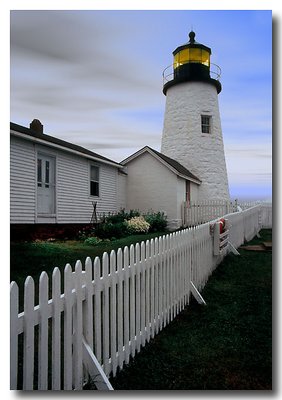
[{"xmin": 10, "ymin": 122, "xmax": 123, "ymax": 168}]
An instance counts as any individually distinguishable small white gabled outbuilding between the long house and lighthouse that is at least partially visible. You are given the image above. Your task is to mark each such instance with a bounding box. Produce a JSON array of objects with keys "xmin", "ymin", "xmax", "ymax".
[{"xmin": 121, "ymin": 146, "xmax": 201, "ymax": 229}]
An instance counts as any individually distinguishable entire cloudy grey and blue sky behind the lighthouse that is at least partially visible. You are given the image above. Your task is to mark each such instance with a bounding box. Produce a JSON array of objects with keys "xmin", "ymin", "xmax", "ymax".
[{"xmin": 10, "ymin": 10, "xmax": 272, "ymax": 199}]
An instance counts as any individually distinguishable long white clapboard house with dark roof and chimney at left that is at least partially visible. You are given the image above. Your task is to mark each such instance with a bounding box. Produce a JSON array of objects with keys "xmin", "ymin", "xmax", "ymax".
[{"xmin": 10, "ymin": 120, "xmax": 126, "ymax": 238}]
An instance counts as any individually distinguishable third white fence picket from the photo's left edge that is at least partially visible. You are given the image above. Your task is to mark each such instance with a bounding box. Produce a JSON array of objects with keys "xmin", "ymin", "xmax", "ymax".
[{"xmin": 38, "ymin": 271, "xmax": 49, "ymax": 390}]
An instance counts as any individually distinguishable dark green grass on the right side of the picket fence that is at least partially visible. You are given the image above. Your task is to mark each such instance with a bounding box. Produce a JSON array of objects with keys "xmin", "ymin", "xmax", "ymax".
[{"xmin": 105, "ymin": 230, "xmax": 272, "ymax": 390}]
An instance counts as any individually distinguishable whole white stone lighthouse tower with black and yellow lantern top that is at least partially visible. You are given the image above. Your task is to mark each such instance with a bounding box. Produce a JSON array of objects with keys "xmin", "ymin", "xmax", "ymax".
[{"xmin": 161, "ymin": 31, "xmax": 230, "ymax": 201}]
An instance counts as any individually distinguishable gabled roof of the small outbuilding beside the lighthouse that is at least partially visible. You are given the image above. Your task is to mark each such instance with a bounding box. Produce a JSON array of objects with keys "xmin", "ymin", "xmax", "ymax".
[{"xmin": 121, "ymin": 146, "xmax": 202, "ymax": 185}]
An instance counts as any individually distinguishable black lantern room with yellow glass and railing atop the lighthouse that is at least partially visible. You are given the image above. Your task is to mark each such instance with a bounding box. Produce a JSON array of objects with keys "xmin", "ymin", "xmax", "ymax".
[{"xmin": 163, "ymin": 31, "xmax": 221, "ymax": 94}]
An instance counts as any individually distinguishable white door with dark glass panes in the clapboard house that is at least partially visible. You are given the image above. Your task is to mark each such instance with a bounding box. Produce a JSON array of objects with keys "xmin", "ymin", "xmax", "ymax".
[{"xmin": 37, "ymin": 154, "xmax": 55, "ymax": 215}]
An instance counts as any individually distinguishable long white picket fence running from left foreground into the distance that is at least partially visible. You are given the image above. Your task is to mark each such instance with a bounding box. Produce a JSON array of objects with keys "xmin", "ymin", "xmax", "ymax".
[{"xmin": 10, "ymin": 206, "xmax": 272, "ymax": 390}]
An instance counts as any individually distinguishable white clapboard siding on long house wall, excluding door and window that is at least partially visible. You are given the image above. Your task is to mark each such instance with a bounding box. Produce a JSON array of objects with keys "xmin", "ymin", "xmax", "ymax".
[{"xmin": 11, "ymin": 137, "xmax": 118, "ymax": 224}]
